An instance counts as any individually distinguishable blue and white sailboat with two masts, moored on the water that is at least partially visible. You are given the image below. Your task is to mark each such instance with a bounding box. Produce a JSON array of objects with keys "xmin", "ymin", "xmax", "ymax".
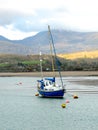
[{"xmin": 37, "ymin": 25, "xmax": 66, "ymax": 98}]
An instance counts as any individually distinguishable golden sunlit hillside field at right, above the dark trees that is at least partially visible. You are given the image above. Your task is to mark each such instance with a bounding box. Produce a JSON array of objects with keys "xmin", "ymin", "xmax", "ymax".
[{"xmin": 58, "ymin": 50, "xmax": 98, "ymax": 60}]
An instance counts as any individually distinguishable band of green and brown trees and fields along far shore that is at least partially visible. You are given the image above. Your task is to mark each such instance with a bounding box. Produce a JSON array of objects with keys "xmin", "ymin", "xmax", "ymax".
[{"xmin": 0, "ymin": 52, "xmax": 98, "ymax": 72}]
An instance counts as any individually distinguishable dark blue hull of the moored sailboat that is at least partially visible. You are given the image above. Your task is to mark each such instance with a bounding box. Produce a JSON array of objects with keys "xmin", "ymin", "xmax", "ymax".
[{"xmin": 38, "ymin": 89, "xmax": 65, "ymax": 98}]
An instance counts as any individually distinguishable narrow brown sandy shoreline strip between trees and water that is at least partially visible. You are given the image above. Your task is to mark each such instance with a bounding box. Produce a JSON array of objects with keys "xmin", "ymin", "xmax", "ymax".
[{"xmin": 0, "ymin": 71, "xmax": 98, "ymax": 77}]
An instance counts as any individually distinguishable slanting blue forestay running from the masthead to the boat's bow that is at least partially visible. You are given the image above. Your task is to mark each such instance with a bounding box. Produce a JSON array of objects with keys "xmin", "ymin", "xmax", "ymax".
[{"xmin": 48, "ymin": 25, "xmax": 64, "ymax": 88}]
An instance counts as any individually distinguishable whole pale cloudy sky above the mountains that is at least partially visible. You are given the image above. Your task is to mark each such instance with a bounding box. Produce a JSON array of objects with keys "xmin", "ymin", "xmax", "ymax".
[{"xmin": 0, "ymin": 0, "xmax": 98, "ymax": 40}]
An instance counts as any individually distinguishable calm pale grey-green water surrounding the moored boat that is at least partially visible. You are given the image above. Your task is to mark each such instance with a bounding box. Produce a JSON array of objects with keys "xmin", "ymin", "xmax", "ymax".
[{"xmin": 0, "ymin": 77, "xmax": 98, "ymax": 130}]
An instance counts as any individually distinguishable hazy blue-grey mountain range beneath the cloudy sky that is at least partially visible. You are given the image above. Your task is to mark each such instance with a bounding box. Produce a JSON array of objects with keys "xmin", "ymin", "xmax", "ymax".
[{"xmin": 0, "ymin": 30, "xmax": 98, "ymax": 55}]
